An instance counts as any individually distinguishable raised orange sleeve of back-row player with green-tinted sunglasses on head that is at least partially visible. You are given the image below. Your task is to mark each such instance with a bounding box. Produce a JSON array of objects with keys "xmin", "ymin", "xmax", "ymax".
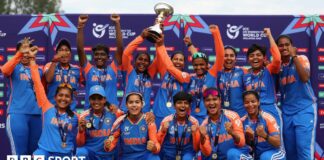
[{"xmin": 208, "ymin": 26, "xmax": 225, "ymax": 77}]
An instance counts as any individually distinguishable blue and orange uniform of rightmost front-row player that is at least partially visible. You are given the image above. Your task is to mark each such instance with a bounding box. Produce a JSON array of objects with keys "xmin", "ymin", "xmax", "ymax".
[{"xmin": 241, "ymin": 111, "xmax": 286, "ymax": 160}]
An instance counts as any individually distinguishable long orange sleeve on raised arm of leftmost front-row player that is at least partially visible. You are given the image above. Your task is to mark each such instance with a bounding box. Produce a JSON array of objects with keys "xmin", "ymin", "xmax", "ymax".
[{"xmin": 30, "ymin": 64, "xmax": 53, "ymax": 113}]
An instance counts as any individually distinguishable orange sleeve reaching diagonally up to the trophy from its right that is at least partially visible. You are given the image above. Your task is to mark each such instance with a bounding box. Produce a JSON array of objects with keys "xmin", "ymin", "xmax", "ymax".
[{"xmin": 156, "ymin": 45, "xmax": 190, "ymax": 83}]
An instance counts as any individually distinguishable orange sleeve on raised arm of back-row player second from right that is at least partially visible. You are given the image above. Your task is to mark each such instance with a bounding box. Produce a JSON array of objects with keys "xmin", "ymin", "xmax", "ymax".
[{"xmin": 267, "ymin": 45, "xmax": 281, "ymax": 74}]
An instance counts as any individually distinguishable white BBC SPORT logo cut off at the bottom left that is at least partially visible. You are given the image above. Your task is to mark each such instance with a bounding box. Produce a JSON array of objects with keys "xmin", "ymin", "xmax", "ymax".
[{"xmin": 7, "ymin": 155, "xmax": 85, "ymax": 160}]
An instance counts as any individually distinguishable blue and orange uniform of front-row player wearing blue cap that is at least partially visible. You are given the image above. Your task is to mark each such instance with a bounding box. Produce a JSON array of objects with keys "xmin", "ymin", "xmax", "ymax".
[{"xmin": 76, "ymin": 108, "xmax": 123, "ymax": 160}]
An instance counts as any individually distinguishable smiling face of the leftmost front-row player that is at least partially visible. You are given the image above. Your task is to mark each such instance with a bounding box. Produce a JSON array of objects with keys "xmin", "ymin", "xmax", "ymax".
[{"xmin": 54, "ymin": 88, "xmax": 72, "ymax": 109}]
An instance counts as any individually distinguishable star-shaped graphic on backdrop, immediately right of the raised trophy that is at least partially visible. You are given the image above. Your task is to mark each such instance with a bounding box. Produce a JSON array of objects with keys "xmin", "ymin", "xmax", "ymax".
[{"xmin": 163, "ymin": 14, "xmax": 210, "ymax": 38}]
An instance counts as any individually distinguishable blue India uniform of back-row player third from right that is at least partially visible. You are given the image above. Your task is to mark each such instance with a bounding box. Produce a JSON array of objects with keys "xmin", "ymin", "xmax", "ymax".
[{"xmin": 217, "ymin": 66, "xmax": 246, "ymax": 117}]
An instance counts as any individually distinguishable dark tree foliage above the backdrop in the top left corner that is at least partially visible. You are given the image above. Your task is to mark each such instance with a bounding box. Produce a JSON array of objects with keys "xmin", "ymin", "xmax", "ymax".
[{"xmin": 0, "ymin": 0, "xmax": 61, "ymax": 14}]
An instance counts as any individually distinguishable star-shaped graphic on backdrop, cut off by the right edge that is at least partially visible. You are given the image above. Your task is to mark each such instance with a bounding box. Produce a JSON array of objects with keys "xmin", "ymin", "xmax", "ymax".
[{"xmin": 281, "ymin": 15, "xmax": 324, "ymax": 46}]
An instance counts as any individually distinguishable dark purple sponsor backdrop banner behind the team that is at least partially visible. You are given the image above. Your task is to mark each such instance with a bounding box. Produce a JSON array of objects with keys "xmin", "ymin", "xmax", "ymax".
[{"xmin": 0, "ymin": 14, "xmax": 324, "ymax": 159}]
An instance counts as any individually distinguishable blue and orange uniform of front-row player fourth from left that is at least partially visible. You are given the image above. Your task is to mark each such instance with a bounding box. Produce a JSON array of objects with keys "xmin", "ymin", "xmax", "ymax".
[{"xmin": 157, "ymin": 114, "xmax": 200, "ymax": 160}]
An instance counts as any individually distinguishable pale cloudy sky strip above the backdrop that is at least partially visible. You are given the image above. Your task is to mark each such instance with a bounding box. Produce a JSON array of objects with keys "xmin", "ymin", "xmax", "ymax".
[{"xmin": 62, "ymin": 0, "xmax": 324, "ymax": 15}]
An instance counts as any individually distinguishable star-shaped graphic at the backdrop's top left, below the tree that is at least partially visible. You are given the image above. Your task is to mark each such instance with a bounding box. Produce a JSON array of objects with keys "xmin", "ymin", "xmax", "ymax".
[{"xmin": 18, "ymin": 13, "xmax": 77, "ymax": 44}]
